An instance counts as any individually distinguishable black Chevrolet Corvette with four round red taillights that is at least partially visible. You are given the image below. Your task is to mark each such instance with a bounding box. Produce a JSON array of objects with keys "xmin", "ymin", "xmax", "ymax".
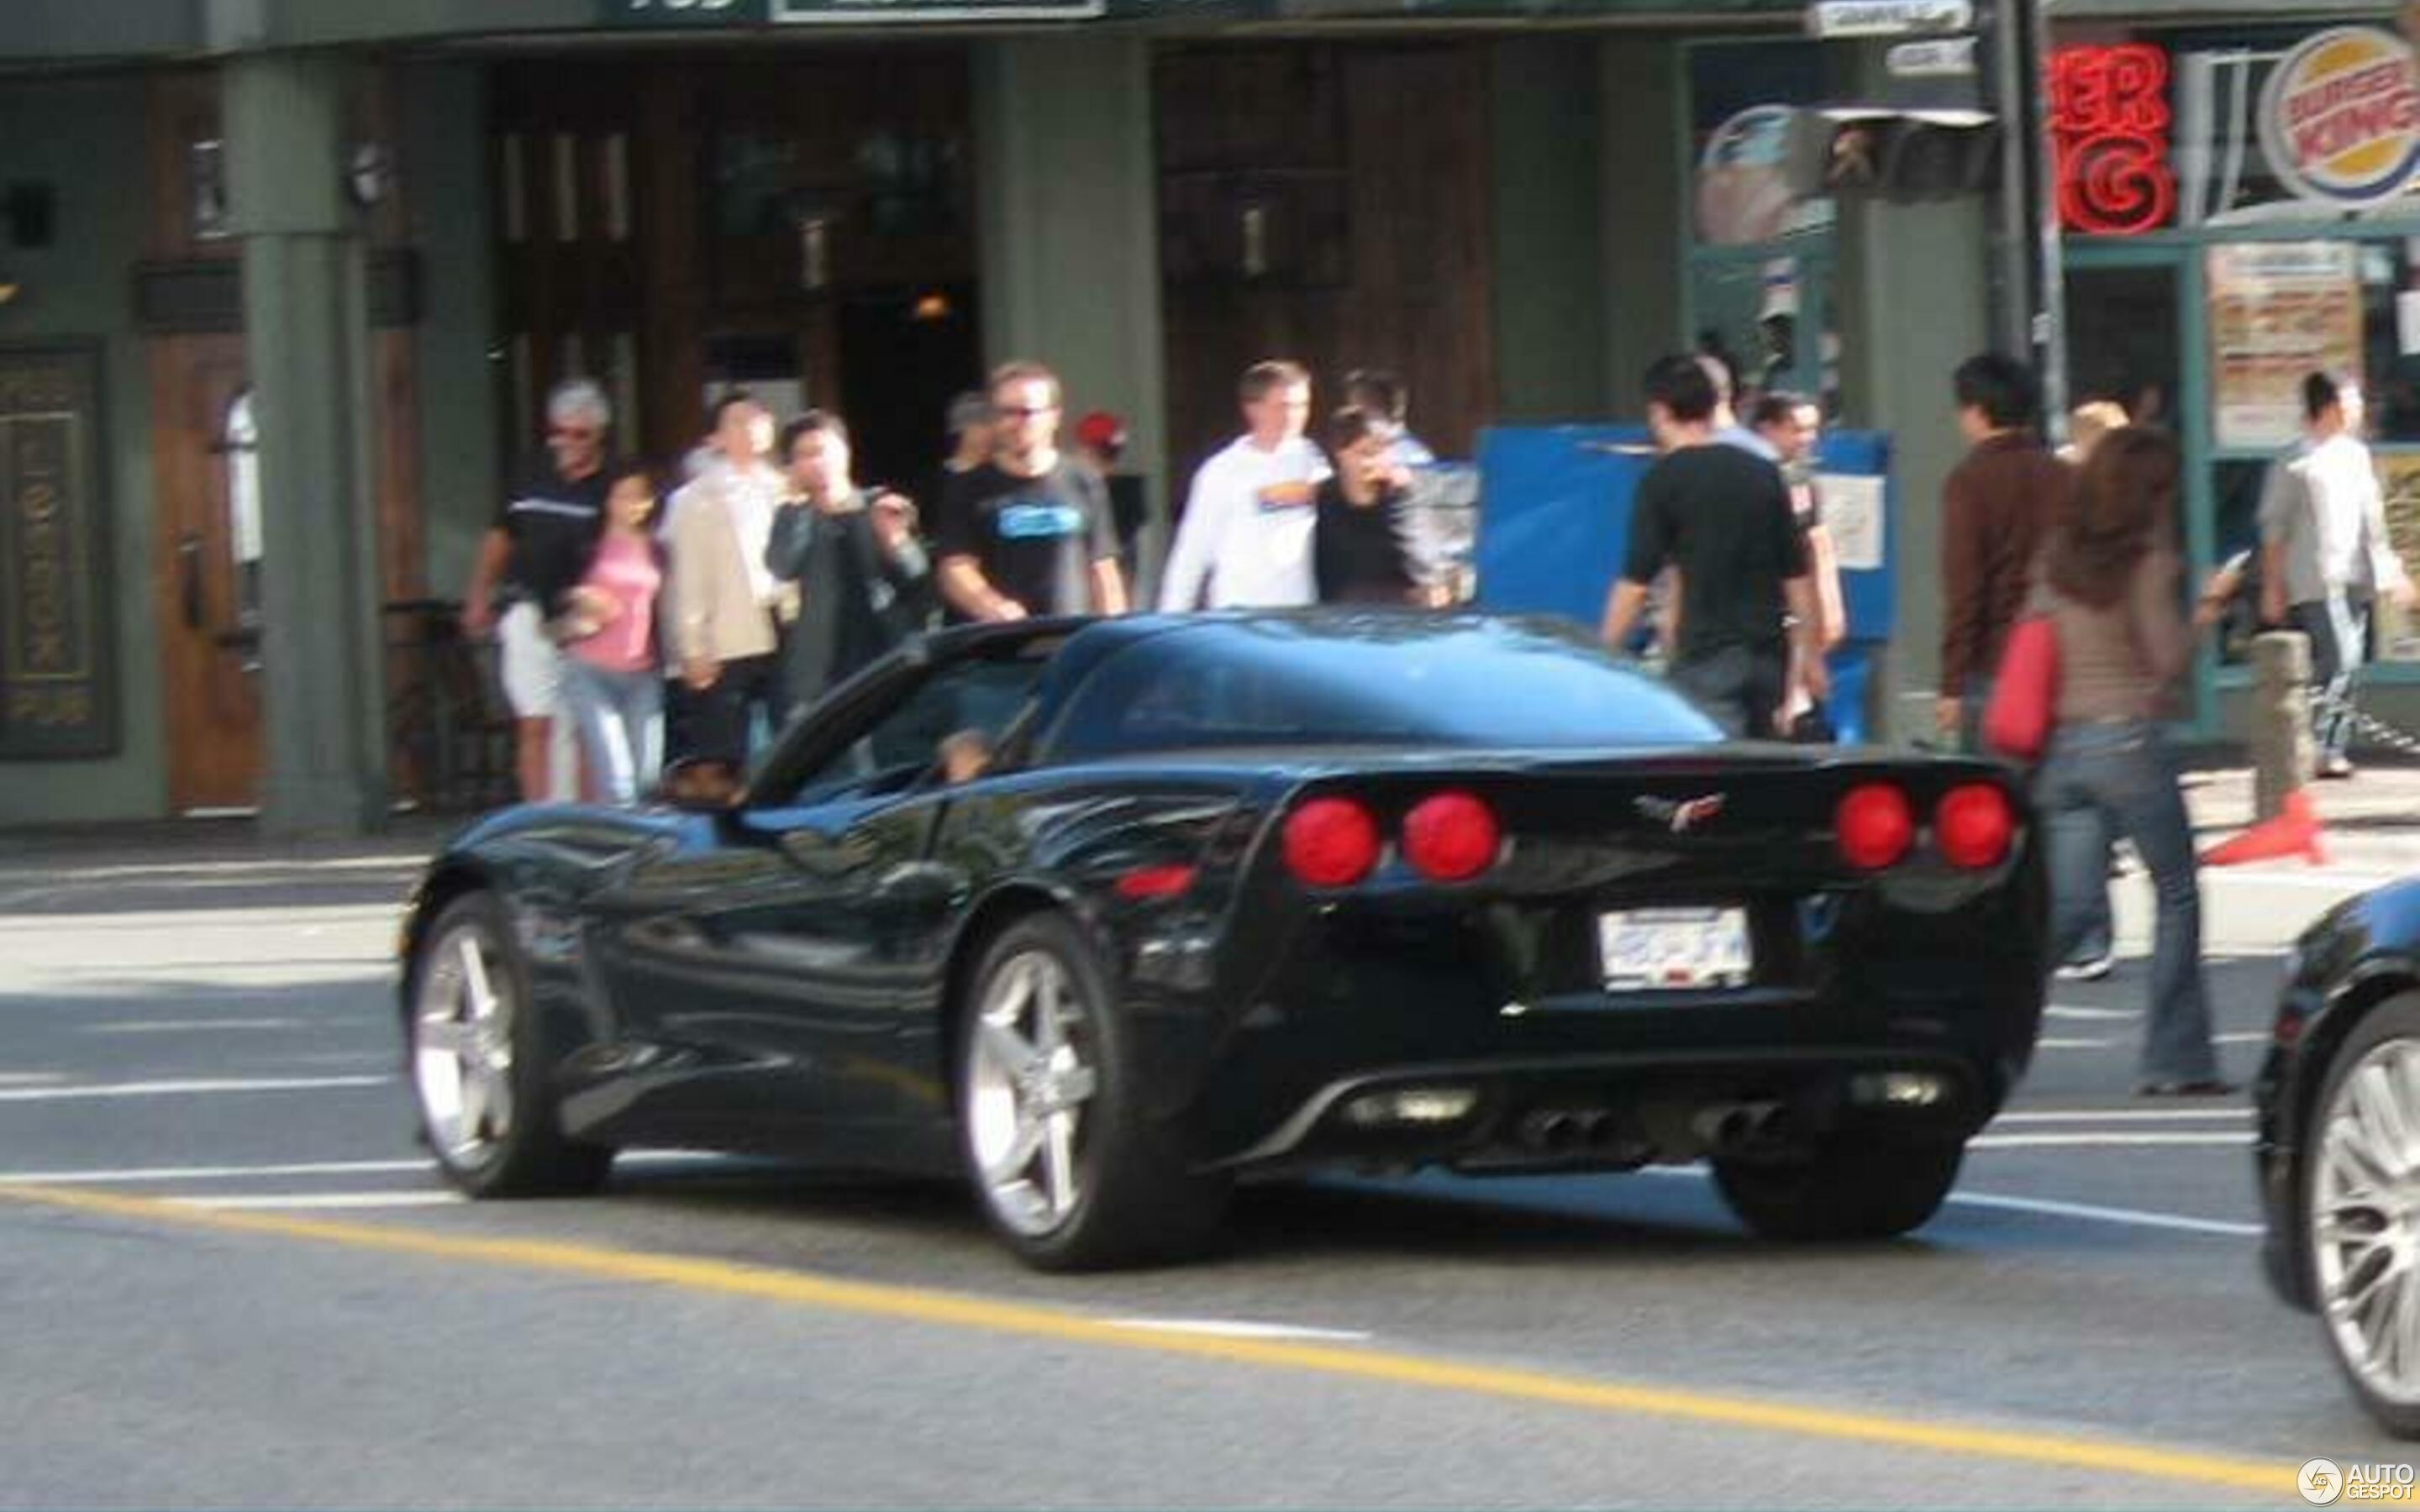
[{"xmin": 402, "ymin": 612, "xmax": 2043, "ymax": 1268}]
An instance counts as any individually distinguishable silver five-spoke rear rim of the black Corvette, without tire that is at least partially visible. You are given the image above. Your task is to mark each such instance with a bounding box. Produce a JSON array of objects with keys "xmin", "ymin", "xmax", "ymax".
[{"xmin": 965, "ymin": 951, "xmax": 1099, "ymax": 1236}]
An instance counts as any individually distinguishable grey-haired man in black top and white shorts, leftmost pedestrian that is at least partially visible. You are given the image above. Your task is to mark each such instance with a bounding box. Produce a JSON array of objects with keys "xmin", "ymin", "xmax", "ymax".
[{"xmin": 462, "ymin": 377, "xmax": 613, "ymax": 803}]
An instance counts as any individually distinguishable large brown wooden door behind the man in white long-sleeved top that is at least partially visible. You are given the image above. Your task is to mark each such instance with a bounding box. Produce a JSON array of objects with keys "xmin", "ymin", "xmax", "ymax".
[{"xmin": 1155, "ymin": 41, "xmax": 1496, "ymax": 476}]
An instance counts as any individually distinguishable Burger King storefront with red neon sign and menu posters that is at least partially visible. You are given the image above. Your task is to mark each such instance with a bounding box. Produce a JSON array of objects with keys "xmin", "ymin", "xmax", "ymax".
[{"xmin": 2045, "ymin": 0, "xmax": 2420, "ymax": 736}]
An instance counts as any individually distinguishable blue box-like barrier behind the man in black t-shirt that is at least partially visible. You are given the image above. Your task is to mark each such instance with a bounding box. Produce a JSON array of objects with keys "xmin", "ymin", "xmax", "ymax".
[{"xmin": 1474, "ymin": 426, "xmax": 1897, "ymax": 743}]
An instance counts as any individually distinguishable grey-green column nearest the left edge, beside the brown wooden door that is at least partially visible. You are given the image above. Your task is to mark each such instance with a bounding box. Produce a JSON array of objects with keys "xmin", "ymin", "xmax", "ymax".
[{"xmin": 225, "ymin": 53, "xmax": 387, "ymax": 835}]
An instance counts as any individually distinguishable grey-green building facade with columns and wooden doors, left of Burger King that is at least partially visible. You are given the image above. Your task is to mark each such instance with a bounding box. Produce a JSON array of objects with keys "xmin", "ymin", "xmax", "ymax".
[{"xmin": 0, "ymin": 0, "xmax": 1986, "ymax": 830}]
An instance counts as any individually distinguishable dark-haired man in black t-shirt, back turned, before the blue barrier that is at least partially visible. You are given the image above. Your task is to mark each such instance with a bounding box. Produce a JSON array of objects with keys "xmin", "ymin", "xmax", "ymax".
[{"xmin": 1604, "ymin": 355, "xmax": 1829, "ymax": 740}]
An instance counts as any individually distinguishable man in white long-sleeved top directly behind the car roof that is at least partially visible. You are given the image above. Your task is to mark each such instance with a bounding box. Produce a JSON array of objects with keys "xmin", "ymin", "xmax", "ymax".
[{"xmin": 1160, "ymin": 363, "xmax": 1328, "ymax": 612}]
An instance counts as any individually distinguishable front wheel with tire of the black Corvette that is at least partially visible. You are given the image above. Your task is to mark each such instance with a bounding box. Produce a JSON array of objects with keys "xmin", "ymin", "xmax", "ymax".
[{"xmin": 404, "ymin": 893, "xmax": 613, "ymax": 1198}]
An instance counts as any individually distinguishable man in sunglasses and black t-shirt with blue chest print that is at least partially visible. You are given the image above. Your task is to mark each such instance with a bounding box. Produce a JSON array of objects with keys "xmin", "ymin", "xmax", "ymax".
[{"xmin": 934, "ymin": 363, "xmax": 1125, "ymax": 619}]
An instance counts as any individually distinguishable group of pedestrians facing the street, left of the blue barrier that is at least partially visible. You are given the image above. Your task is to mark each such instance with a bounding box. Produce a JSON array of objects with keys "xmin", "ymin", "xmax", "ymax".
[{"xmin": 462, "ymin": 360, "xmax": 1444, "ymax": 803}]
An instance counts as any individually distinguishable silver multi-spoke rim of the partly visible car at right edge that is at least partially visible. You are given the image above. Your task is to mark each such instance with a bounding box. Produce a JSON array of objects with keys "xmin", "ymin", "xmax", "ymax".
[{"xmin": 2309, "ymin": 1038, "xmax": 2420, "ymax": 1403}]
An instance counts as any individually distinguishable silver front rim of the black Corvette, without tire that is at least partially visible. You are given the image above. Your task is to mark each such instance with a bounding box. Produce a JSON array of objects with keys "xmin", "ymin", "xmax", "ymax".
[{"xmin": 412, "ymin": 921, "xmax": 518, "ymax": 1166}]
